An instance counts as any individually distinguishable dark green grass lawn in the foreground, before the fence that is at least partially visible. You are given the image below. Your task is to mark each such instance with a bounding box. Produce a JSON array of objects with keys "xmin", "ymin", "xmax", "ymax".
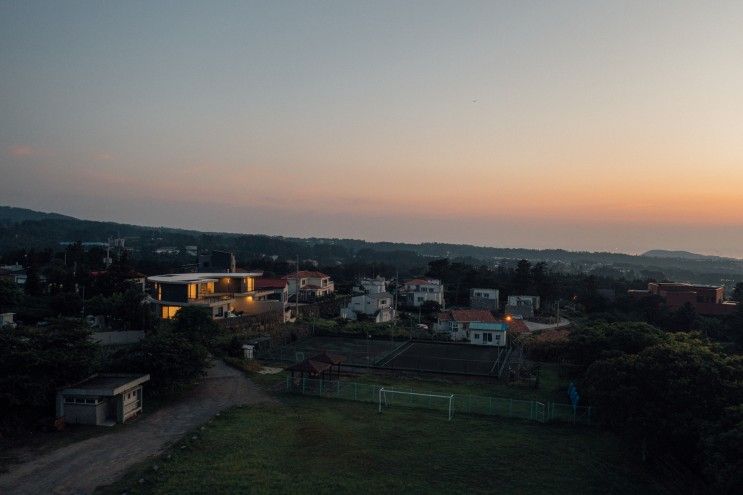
[{"xmin": 98, "ymin": 395, "xmax": 661, "ymax": 495}]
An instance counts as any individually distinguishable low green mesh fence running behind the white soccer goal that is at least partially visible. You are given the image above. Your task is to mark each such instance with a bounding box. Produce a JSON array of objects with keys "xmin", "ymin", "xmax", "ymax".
[{"xmin": 286, "ymin": 376, "xmax": 594, "ymax": 424}]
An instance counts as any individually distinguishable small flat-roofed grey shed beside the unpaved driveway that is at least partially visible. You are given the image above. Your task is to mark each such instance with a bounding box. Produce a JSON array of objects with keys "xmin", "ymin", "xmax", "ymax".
[{"xmin": 57, "ymin": 373, "xmax": 150, "ymax": 426}]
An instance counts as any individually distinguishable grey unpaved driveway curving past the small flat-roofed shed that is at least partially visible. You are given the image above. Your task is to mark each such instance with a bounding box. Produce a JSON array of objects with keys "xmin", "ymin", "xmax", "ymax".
[{"xmin": 0, "ymin": 361, "xmax": 272, "ymax": 494}]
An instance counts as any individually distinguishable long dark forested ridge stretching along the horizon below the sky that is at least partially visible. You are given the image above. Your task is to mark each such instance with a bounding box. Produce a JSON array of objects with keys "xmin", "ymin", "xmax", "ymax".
[{"xmin": 0, "ymin": 206, "xmax": 743, "ymax": 285}]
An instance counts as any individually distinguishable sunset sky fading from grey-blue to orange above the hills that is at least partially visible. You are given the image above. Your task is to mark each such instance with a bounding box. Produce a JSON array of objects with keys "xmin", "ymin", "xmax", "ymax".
[{"xmin": 0, "ymin": 0, "xmax": 743, "ymax": 257}]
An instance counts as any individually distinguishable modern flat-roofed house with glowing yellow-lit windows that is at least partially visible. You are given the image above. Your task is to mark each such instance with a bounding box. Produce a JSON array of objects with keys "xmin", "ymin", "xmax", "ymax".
[{"xmin": 147, "ymin": 272, "xmax": 284, "ymax": 319}]
